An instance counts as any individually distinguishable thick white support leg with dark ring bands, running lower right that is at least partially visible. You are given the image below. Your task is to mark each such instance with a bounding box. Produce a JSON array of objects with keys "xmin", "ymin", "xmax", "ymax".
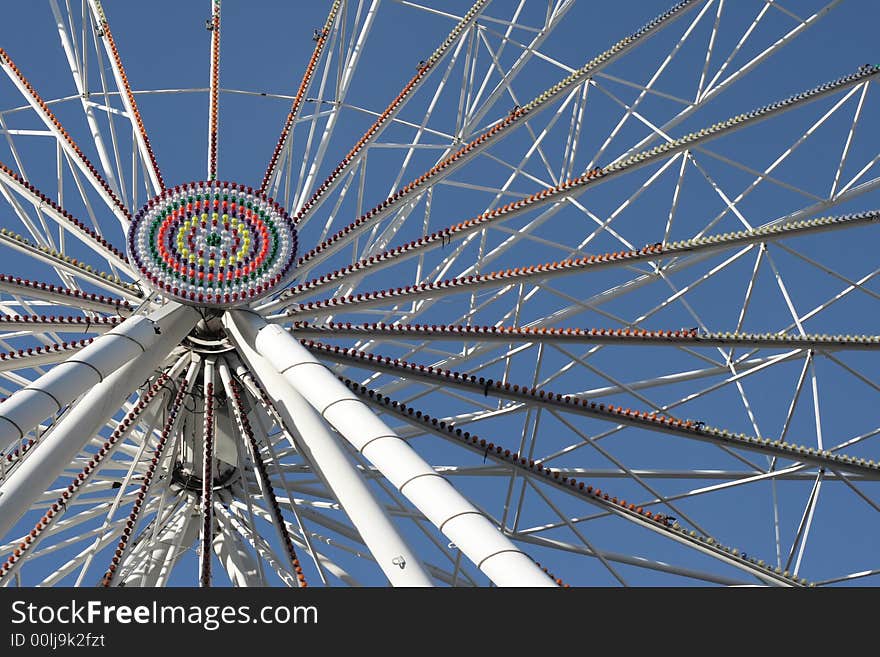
[{"xmin": 225, "ymin": 311, "xmax": 554, "ymax": 587}]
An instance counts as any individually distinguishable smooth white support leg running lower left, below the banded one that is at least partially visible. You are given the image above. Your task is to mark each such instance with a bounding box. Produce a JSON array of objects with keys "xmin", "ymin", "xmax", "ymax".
[{"xmin": 0, "ymin": 303, "xmax": 200, "ymax": 536}]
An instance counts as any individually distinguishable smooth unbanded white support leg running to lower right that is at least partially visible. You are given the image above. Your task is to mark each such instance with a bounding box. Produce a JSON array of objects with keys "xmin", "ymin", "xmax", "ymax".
[{"xmin": 220, "ymin": 323, "xmax": 433, "ymax": 586}]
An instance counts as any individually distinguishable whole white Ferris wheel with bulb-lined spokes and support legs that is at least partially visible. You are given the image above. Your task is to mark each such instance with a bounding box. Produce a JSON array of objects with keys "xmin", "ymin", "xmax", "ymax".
[{"xmin": 0, "ymin": 0, "xmax": 880, "ymax": 587}]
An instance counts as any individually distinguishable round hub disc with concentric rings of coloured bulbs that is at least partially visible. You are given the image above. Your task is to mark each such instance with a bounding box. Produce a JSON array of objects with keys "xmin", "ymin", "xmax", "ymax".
[{"xmin": 128, "ymin": 181, "xmax": 297, "ymax": 308}]
